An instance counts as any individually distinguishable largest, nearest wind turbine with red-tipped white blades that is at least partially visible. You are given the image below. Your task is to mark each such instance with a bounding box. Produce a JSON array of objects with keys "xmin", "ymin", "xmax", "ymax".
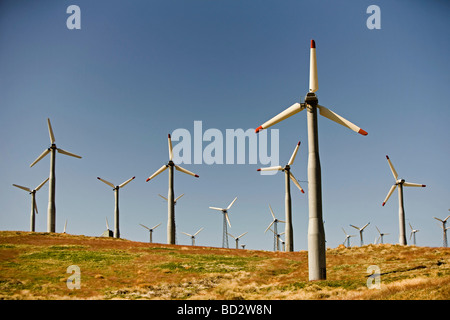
[{"xmin": 256, "ymin": 40, "xmax": 367, "ymax": 280}]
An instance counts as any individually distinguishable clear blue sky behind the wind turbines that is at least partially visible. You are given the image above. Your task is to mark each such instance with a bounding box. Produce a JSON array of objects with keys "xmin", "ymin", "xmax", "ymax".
[{"xmin": 0, "ymin": 0, "xmax": 450, "ymax": 250}]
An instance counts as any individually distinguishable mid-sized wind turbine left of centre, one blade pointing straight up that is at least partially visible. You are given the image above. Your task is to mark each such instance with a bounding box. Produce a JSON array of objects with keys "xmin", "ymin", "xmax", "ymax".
[{"xmin": 146, "ymin": 134, "xmax": 198, "ymax": 244}]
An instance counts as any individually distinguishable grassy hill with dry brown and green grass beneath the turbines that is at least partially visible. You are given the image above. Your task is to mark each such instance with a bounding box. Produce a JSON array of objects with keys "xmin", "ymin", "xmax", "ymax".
[{"xmin": 0, "ymin": 231, "xmax": 450, "ymax": 300}]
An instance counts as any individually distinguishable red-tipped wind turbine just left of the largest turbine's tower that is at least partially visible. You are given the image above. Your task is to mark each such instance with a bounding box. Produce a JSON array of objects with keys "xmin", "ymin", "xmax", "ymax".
[{"xmin": 257, "ymin": 141, "xmax": 305, "ymax": 251}]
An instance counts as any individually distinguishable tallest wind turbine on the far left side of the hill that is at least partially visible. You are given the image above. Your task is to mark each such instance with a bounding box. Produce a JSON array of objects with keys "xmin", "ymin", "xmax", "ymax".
[{"xmin": 30, "ymin": 118, "xmax": 81, "ymax": 232}]
